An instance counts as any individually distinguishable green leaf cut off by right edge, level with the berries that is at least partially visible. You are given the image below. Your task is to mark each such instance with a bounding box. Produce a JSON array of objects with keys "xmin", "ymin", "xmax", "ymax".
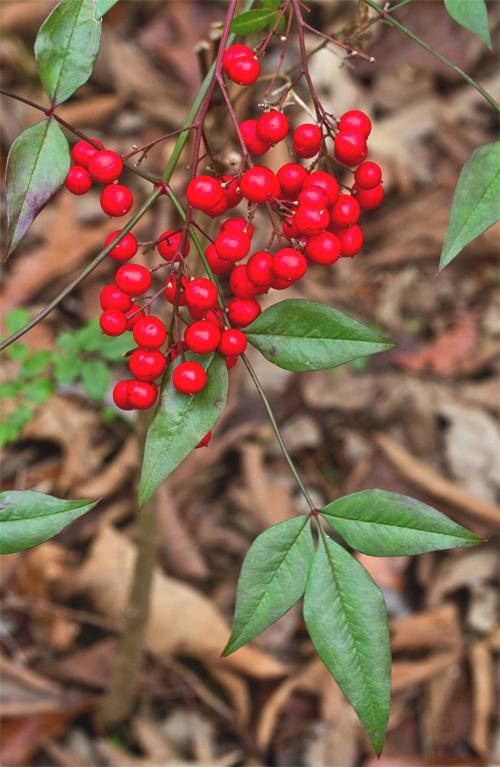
[{"xmin": 439, "ymin": 142, "xmax": 500, "ymax": 269}]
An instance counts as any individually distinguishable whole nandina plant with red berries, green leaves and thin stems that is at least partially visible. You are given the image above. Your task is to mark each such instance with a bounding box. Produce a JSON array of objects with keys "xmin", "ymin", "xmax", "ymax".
[{"xmin": 0, "ymin": 0, "xmax": 498, "ymax": 753}]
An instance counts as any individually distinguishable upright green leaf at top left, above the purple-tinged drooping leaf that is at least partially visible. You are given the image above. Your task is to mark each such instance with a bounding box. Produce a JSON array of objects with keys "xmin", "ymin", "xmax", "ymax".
[{"xmin": 35, "ymin": 0, "xmax": 102, "ymax": 106}]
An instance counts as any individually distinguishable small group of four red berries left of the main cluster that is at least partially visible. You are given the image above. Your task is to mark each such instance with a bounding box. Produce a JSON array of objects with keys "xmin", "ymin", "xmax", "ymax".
[{"xmin": 64, "ymin": 138, "xmax": 134, "ymax": 217}]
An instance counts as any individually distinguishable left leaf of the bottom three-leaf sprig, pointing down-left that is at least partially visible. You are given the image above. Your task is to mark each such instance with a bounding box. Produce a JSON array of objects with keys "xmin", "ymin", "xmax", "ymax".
[{"xmin": 222, "ymin": 517, "xmax": 314, "ymax": 655}]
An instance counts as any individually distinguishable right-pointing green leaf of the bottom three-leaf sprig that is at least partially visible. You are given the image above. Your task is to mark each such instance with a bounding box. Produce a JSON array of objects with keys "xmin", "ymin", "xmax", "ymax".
[{"xmin": 321, "ymin": 490, "xmax": 481, "ymax": 557}]
